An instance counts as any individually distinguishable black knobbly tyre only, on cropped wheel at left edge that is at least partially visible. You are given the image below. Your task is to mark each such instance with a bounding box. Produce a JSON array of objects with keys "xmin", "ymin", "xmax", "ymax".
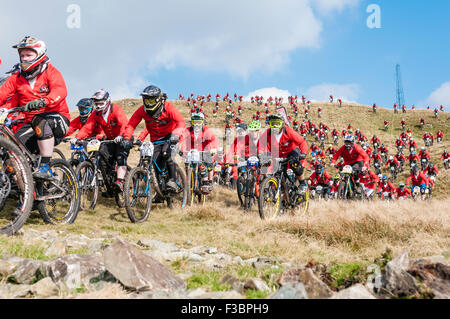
[{"xmin": 0, "ymin": 136, "xmax": 34, "ymax": 236}]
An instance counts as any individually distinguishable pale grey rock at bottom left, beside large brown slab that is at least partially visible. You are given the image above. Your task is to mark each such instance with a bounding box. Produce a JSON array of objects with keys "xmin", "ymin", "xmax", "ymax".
[{"xmin": 47, "ymin": 253, "xmax": 106, "ymax": 289}]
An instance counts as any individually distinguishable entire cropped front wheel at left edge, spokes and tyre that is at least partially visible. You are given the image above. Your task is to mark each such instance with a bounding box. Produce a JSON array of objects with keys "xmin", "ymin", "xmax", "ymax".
[{"xmin": 0, "ymin": 137, "xmax": 34, "ymax": 235}]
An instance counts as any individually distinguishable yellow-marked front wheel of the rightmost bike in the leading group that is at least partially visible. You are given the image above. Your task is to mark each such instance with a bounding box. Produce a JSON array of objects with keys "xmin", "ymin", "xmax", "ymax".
[{"xmin": 258, "ymin": 177, "xmax": 281, "ymax": 220}]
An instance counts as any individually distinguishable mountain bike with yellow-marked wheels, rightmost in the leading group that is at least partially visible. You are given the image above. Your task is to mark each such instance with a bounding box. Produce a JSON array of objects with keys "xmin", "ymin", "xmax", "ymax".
[{"xmin": 258, "ymin": 158, "xmax": 309, "ymax": 220}]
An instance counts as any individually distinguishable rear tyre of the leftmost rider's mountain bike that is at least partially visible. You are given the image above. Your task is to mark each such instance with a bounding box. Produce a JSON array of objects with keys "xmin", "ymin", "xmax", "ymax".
[{"xmin": 37, "ymin": 159, "xmax": 80, "ymax": 225}]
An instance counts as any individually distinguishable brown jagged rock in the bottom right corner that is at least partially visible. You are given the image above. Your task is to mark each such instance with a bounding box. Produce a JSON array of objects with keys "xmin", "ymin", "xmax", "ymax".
[{"xmin": 408, "ymin": 260, "xmax": 450, "ymax": 299}]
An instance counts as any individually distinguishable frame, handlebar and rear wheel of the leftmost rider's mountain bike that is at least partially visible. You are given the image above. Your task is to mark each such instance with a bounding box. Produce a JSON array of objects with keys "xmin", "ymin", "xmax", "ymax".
[{"xmin": 0, "ymin": 107, "xmax": 80, "ymax": 225}]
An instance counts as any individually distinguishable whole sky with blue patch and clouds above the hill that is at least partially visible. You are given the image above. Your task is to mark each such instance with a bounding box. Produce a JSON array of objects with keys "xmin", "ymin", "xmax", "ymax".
[{"xmin": 0, "ymin": 0, "xmax": 450, "ymax": 107}]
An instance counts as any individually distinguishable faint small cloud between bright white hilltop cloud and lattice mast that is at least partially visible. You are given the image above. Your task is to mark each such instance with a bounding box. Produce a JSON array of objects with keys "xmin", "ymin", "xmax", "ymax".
[{"xmin": 305, "ymin": 83, "xmax": 361, "ymax": 103}]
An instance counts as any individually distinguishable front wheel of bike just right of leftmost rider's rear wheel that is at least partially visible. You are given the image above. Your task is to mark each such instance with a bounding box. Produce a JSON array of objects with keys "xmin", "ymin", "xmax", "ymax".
[{"xmin": 75, "ymin": 161, "xmax": 99, "ymax": 211}]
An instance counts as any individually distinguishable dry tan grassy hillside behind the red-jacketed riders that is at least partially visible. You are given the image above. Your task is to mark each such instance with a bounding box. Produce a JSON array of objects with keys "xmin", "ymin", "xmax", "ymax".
[{"xmin": 64, "ymin": 99, "xmax": 450, "ymax": 198}]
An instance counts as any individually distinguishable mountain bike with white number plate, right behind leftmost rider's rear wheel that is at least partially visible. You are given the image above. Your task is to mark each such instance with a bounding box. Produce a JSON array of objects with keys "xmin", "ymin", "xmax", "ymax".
[{"xmin": 75, "ymin": 139, "xmax": 130, "ymax": 210}]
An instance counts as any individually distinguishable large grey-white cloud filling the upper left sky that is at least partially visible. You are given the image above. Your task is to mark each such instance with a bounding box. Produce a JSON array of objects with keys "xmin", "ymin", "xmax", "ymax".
[{"xmin": 0, "ymin": 0, "xmax": 356, "ymax": 106}]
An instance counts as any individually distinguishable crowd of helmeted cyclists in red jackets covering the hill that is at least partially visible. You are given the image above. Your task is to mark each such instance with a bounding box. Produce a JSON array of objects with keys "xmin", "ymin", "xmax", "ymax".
[{"xmin": 0, "ymin": 37, "xmax": 449, "ymax": 232}]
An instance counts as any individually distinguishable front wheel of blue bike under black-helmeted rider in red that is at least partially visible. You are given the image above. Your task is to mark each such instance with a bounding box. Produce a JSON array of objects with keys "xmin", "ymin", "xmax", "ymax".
[{"xmin": 123, "ymin": 167, "xmax": 152, "ymax": 223}]
